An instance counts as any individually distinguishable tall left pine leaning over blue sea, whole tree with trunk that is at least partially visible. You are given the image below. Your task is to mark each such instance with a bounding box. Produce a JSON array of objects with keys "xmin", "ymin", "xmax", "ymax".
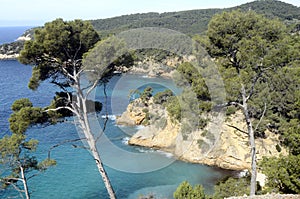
[{"xmin": 19, "ymin": 19, "xmax": 119, "ymax": 198}]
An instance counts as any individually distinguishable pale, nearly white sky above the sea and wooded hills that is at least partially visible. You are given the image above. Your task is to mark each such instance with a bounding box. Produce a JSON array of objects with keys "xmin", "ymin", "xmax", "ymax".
[{"xmin": 0, "ymin": 0, "xmax": 300, "ymax": 26}]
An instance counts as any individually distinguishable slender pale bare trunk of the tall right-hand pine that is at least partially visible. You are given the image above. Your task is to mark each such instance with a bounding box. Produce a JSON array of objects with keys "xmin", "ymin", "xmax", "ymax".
[{"xmin": 242, "ymin": 86, "xmax": 256, "ymax": 196}]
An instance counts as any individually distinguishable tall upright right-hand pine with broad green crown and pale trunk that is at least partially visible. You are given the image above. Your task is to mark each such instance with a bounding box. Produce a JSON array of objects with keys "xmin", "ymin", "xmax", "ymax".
[{"xmin": 207, "ymin": 11, "xmax": 289, "ymax": 195}]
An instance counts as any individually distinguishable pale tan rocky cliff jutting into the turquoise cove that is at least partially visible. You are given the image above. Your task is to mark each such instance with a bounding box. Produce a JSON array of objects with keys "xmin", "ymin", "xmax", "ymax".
[{"xmin": 117, "ymin": 98, "xmax": 286, "ymax": 170}]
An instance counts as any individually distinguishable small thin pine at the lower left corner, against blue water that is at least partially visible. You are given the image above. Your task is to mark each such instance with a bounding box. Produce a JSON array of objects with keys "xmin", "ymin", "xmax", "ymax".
[{"xmin": 0, "ymin": 99, "xmax": 56, "ymax": 199}]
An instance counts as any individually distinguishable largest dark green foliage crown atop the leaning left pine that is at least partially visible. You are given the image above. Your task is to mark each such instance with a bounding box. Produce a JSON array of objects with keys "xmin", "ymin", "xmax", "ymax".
[{"xmin": 19, "ymin": 19, "xmax": 99, "ymax": 89}]
